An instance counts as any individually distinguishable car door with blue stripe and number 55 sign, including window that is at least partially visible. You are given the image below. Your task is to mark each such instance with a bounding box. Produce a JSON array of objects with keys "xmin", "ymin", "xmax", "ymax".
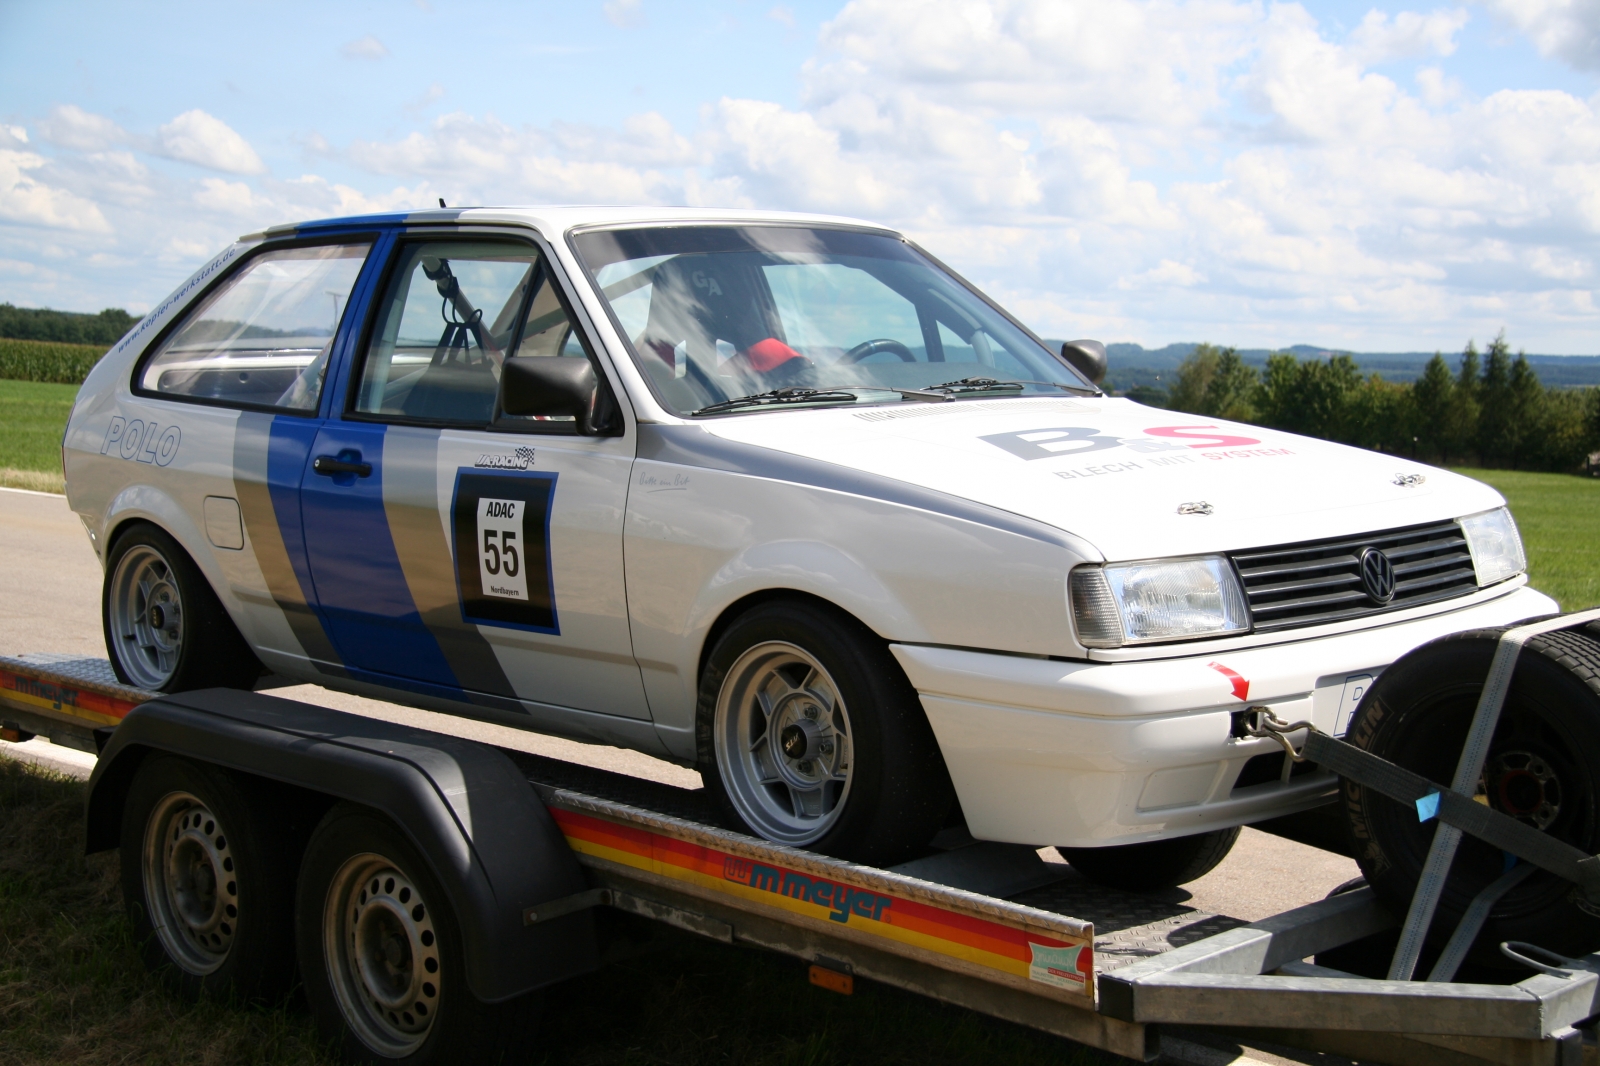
[{"xmin": 302, "ymin": 237, "xmax": 650, "ymax": 719}]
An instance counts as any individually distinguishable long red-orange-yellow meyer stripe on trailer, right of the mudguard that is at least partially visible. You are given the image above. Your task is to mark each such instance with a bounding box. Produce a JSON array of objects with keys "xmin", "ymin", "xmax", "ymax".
[{"xmin": 550, "ymin": 807, "xmax": 1094, "ymax": 996}]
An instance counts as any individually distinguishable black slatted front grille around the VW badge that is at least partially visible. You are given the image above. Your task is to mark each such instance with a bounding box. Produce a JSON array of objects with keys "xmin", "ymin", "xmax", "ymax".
[{"xmin": 1230, "ymin": 522, "xmax": 1478, "ymax": 632}]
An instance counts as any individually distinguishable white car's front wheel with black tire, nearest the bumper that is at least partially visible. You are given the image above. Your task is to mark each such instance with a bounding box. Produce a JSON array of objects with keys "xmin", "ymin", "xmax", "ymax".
[{"xmin": 696, "ymin": 600, "xmax": 955, "ymax": 864}]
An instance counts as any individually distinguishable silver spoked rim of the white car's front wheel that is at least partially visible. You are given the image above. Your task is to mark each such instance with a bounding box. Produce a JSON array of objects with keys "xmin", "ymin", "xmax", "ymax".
[{"xmin": 714, "ymin": 640, "xmax": 854, "ymax": 847}]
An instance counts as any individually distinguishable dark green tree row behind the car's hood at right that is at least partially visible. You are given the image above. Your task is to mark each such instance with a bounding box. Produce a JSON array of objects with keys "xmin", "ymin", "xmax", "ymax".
[{"xmin": 1130, "ymin": 331, "xmax": 1600, "ymax": 471}]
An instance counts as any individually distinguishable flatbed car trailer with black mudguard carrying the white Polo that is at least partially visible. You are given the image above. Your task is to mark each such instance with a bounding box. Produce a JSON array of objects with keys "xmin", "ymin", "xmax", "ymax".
[{"xmin": 0, "ymin": 610, "xmax": 1600, "ymax": 1066}]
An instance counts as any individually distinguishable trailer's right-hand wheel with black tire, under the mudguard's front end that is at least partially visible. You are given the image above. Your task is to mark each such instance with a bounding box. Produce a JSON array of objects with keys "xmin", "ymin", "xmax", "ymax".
[{"xmin": 294, "ymin": 804, "xmax": 542, "ymax": 1066}]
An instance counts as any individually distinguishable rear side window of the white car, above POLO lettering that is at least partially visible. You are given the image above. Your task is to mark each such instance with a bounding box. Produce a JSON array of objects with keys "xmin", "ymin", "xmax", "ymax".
[{"xmin": 138, "ymin": 243, "xmax": 371, "ymax": 411}]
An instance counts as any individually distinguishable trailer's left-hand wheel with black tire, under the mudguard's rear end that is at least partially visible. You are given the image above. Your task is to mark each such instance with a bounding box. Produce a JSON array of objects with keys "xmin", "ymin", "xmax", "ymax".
[{"xmin": 120, "ymin": 754, "xmax": 294, "ymax": 1002}]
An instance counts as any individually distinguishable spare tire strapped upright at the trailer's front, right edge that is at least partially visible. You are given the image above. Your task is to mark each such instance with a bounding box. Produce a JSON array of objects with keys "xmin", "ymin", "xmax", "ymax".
[{"xmin": 1341, "ymin": 626, "xmax": 1600, "ymax": 968}]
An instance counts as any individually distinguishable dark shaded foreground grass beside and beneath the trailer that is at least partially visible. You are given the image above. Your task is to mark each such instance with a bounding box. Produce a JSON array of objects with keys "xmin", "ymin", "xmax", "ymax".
[{"xmin": 0, "ymin": 757, "xmax": 1122, "ymax": 1066}]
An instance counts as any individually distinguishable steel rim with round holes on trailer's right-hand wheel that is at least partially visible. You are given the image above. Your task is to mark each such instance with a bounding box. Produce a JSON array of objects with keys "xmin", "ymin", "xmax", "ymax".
[{"xmin": 322, "ymin": 853, "xmax": 443, "ymax": 1058}]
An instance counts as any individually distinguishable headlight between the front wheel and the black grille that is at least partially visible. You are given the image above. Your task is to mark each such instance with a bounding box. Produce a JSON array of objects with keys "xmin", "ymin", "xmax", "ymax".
[{"xmin": 1070, "ymin": 555, "xmax": 1250, "ymax": 648}]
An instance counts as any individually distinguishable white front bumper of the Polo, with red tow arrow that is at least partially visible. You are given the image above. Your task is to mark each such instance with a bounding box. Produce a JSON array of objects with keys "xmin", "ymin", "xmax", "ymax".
[{"xmin": 891, "ymin": 587, "xmax": 1558, "ymax": 847}]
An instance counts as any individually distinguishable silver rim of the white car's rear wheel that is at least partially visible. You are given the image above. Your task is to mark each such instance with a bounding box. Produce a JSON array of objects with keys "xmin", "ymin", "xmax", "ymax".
[{"xmin": 107, "ymin": 544, "xmax": 184, "ymax": 690}]
